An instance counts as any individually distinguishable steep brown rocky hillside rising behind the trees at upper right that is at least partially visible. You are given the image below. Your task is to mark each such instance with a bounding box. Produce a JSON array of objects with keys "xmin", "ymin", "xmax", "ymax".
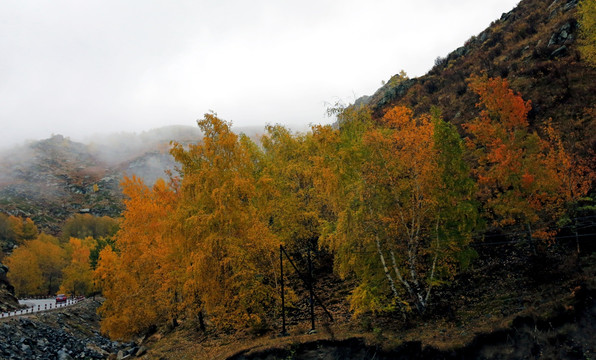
[{"xmin": 357, "ymin": 0, "xmax": 596, "ymax": 153}]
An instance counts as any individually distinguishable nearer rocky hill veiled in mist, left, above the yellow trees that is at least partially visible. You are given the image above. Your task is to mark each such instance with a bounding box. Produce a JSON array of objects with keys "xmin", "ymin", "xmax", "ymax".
[{"xmin": 0, "ymin": 135, "xmax": 120, "ymax": 233}]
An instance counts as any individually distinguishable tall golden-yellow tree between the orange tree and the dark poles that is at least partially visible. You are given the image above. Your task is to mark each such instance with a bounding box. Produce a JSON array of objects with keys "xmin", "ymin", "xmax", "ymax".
[{"xmin": 172, "ymin": 114, "xmax": 278, "ymax": 329}]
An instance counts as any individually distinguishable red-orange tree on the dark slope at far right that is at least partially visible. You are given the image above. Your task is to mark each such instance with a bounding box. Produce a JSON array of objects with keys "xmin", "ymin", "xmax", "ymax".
[{"xmin": 465, "ymin": 76, "xmax": 590, "ymax": 252}]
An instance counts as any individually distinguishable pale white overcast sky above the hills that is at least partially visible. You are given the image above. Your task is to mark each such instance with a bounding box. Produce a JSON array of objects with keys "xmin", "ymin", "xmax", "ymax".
[{"xmin": 0, "ymin": 0, "xmax": 518, "ymax": 148}]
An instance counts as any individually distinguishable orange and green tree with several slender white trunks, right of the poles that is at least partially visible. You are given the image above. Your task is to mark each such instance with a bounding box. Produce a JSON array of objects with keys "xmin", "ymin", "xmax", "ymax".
[{"xmin": 329, "ymin": 107, "xmax": 476, "ymax": 314}]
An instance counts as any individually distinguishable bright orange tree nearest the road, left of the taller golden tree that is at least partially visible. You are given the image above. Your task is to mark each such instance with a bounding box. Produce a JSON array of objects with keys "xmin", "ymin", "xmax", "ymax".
[{"xmin": 94, "ymin": 176, "xmax": 179, "ymax": 339}]
